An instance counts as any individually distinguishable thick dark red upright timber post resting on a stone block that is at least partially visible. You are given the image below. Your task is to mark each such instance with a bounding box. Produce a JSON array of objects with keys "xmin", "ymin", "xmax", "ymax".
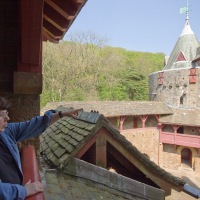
[{"xmin": 17, "ymin": 0, "xmax": 43, "ymax": 69}]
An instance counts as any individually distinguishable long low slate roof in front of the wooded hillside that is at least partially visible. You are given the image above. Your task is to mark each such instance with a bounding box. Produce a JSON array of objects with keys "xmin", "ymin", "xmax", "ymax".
[{"xmin": 41, "ymin": 101, "xmax": 172, "ymax": 118}]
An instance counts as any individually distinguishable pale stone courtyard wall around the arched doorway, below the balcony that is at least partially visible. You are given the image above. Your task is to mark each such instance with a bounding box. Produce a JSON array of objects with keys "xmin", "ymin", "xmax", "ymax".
[{"xmin": 121, "ymin": 128, "xmax": 200, "ymax": 172}]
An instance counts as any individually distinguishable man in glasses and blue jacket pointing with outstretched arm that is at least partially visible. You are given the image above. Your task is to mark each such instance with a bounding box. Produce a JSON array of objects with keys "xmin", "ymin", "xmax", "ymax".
[{"xmin": 0, "ymin": 97, "xmax": 82, "ymax": 200}]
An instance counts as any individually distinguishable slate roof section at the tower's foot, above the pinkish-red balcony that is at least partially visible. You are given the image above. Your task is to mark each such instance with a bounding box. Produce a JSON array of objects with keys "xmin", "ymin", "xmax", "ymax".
[{"xmin": 159, "ymin": 108, "xmax": 200, "ymax": 127}]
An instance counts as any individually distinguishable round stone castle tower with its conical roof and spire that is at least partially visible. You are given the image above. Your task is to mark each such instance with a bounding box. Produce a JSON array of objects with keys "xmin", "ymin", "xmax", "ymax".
[{"xmin": 149, "ymin": 6, "xmax": 200, "ymax": 108}]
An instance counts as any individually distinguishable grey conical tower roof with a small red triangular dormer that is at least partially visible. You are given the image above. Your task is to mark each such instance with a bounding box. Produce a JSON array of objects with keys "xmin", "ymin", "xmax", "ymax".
[{"xmin": 163, "ymin": 16, "xmax": 200, "ymax": 70}]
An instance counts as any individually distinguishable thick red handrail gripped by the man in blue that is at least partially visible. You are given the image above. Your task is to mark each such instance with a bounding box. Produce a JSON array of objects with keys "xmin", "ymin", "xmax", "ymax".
[{"xmin": 21, "ymin": 145, "xmax": 45, "ymax": 200}]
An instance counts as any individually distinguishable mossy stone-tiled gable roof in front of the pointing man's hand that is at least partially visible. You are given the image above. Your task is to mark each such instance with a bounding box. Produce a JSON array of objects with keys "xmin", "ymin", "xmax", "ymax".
[{"xmin": 40, "ymin": 111, "xmax": 185, "ymax": 186}]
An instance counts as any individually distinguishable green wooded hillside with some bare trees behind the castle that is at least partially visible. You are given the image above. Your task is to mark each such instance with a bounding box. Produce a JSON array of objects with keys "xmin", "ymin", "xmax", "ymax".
[{"xmin": 41, "ymin": 32, "xmax": 165, "ymax": 106}]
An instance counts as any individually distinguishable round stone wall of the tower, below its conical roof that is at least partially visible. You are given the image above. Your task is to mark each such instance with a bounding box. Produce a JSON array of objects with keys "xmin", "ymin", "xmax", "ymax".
[{"xmin": 149, "ymin": 67, "xmax": 200, "ymax": 107}]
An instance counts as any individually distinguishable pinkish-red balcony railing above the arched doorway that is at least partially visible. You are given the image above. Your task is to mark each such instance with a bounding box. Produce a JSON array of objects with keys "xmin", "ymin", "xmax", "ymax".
[{"xmin": 160, "ymin": 132, "xmax": 200, "ymax": 148}]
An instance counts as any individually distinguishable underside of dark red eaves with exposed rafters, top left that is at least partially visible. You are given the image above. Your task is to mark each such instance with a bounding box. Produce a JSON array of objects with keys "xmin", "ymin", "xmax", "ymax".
[{"xmin": 43, "ymin": 0, "xmax": 87, "ymax": 43}]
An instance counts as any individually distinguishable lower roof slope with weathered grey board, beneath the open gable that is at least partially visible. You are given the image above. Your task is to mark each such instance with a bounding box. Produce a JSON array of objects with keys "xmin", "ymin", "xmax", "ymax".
[{"xmin": 45, "ymin": 158, "xmax": 164, "ymax": 200}]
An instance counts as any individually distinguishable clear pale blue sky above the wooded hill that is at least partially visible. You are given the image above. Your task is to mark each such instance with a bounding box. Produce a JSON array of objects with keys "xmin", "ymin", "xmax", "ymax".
[{"xmin": 64, "ymin": 0, "xmax": 200, "ymax": 55}]
